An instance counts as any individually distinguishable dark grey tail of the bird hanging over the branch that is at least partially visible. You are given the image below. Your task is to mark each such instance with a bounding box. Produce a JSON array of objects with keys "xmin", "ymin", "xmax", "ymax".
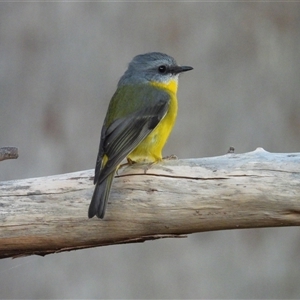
[{"xmin": 88, "ymin": 172, "xmax": 115, "ymax": 219}]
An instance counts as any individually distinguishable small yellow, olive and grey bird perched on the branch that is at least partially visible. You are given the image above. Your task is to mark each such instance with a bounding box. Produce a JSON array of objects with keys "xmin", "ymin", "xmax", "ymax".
[{"xmin": 88, "ymin": 52, "xmax": 193, "ymax": 219}]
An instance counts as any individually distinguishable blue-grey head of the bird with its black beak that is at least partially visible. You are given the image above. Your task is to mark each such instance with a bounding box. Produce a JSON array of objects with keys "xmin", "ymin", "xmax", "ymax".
[{"xmin": 118, "ymin": 52, "xmax": 193, "ymax": 86}]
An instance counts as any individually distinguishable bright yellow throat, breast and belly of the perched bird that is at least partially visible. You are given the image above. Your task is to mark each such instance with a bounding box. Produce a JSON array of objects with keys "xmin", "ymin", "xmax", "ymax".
[{"xmin": 127, "ymin": 80, "xmax": 178, "ymax": 163}]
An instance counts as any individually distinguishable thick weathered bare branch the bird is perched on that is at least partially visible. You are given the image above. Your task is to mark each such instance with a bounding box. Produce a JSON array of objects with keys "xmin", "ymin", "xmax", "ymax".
[{"xmin": 0, "ymin": 148, "xmax": 300, "ymax": 258}]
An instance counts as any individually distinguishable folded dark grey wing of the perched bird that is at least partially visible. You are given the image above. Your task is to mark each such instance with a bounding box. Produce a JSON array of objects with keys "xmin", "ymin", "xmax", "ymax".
[{"xmin": 94, "ymin": 94, "xmax": 170, "ymax": 183}]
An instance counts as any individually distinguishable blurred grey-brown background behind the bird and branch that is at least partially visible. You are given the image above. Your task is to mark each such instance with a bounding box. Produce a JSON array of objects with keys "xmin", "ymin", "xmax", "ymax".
[{"xmin": 0, "ymin": 2, "xmax": 300, "ymax": 299}]
